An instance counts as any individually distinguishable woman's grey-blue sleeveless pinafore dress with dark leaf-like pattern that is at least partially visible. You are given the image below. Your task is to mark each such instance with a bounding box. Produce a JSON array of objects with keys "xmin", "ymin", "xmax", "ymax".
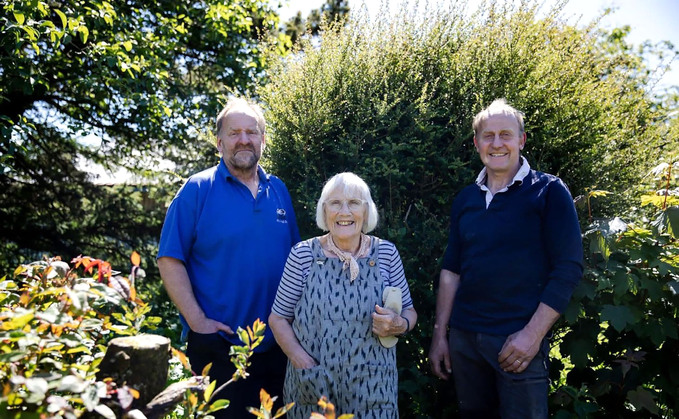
[{"xmin": 283, "ymin": 237, "xmax": 398, "ymax": 419}]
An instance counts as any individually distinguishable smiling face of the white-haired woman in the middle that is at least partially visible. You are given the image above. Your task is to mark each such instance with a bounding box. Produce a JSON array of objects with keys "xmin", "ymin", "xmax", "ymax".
[{"xmin": 323, "ymin": 190, "xmax": 367, "ymax": 246}]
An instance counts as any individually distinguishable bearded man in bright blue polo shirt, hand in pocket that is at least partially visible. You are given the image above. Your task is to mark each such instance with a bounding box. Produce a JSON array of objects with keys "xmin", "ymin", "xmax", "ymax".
[{"xmin": 158, "ymin": 98, "xmax": 300, "ymax": 418}]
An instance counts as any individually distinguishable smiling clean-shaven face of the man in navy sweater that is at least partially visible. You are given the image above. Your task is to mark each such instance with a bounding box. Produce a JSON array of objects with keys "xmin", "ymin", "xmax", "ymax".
[{"xmin": 474, "ymin": 113, "xmax": 526, "ymax": 179}]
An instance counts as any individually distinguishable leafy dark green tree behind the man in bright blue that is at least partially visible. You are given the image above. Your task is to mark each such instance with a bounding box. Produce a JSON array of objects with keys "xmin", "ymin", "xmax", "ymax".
[{"xmin": 0, "ymin": 0, "xmax": 286, "ymax": 270}]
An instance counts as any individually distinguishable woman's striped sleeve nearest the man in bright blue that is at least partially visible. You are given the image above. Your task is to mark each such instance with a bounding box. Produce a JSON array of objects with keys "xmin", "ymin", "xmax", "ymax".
[{"xmin": 271, "ymin": 241, "xmax": 313, "ymax": 319}]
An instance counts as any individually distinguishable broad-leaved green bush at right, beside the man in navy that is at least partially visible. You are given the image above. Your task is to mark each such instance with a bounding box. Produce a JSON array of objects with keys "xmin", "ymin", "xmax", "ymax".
[{"xmin": 551, "ymin": 161, "xmax": 679, "ymax": 418}]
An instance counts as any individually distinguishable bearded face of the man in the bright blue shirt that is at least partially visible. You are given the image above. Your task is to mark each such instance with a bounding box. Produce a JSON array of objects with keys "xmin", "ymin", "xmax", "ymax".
[{"xmin": 217, "ymin": 108, "xmax": 265, "ymax": 173}]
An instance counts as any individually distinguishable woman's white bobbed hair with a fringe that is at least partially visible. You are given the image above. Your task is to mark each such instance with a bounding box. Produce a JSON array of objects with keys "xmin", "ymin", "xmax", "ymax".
[{"xmin": 316, "ymin": 172, "xmax": 378, "ymax": 233}]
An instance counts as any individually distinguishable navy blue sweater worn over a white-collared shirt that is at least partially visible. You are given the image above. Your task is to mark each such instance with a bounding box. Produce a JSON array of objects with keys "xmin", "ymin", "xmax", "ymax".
[{"xmin": 442, "ymin": 170, "xmax": 583, "ymax": 335}]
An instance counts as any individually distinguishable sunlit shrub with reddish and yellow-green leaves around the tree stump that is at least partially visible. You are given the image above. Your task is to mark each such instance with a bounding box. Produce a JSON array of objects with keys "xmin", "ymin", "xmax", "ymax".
[{"xmin": 0, "ymin": 252, "xmax": 271, "ymax": 419}]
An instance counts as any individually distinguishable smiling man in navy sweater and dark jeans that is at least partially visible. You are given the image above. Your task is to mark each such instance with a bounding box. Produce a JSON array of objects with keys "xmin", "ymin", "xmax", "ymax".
[{"xmin": 429, "ymin": 99, "xmax": 583, "ymax": 419}]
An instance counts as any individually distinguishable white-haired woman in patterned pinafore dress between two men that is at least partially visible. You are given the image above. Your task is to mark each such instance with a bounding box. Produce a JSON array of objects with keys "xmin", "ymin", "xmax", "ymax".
[{"xmin": 269, "ymin": 172, "xmax": 417, "ymax": 419}]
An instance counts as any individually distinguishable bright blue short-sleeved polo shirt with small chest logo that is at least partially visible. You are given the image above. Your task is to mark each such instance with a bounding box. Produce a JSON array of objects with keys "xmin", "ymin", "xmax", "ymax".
[{"xmin": 158, "ymin": 160, "xmax": 300, "ymax": 352}]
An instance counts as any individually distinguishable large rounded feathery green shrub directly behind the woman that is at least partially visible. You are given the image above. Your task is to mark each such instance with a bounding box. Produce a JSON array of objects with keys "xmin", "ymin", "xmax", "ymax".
[{"xmin": 258, "ymin": 2, "xmax": 671, "ymax": 417}]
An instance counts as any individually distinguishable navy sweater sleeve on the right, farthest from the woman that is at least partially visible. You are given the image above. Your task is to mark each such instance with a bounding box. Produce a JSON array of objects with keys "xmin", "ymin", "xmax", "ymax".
[{"xmin": 540, "ymin": 179, "xmax": 583, "ymax": 313}]
